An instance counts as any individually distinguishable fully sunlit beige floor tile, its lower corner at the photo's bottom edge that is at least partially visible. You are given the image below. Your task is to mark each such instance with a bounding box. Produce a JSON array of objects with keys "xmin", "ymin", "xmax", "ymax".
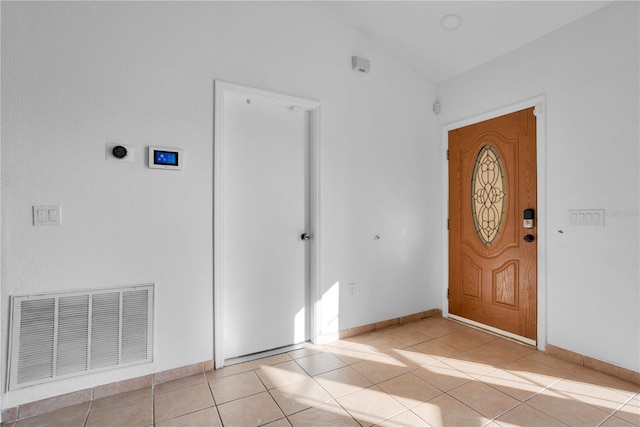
[{"xmin": 338, "ymin": 386, "xmax": 406, "ymax": 426}]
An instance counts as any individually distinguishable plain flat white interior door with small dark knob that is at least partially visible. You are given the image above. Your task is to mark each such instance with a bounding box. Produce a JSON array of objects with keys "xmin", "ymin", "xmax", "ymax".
[{"xmin": 220, "ymin": 93, "xmax": 310, "ymax": 359}]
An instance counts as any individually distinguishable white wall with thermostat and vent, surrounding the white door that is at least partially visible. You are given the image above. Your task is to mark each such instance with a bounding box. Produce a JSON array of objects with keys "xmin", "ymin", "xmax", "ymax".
[{"xmin": 0, "ymin": 2, "xmax": 438, "ymax": 408}]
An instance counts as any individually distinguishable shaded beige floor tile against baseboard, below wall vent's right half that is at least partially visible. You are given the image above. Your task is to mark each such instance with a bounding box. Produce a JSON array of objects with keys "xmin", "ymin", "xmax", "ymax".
[{"xmin": 86, "ymin": 397, "xmax": 153, "ymax": 427}]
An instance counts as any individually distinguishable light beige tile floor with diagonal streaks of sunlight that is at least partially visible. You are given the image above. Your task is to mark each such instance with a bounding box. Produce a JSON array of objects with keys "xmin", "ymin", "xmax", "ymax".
[{"xmin": 5, "ymin": 318, "xmax": 640, "ymax": 427}]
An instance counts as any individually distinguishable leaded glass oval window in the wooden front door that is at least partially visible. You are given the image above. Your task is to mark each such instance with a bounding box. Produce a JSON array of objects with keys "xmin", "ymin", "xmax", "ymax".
[{"xmin": 471, "ymin": 145, "xmax": 507, "ymax": 246}]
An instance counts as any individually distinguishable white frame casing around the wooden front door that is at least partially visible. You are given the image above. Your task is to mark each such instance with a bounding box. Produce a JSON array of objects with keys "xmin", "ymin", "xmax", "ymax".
[{"xmin": 442, "ymin": 95, "xmax": 547, "ymax": 351}]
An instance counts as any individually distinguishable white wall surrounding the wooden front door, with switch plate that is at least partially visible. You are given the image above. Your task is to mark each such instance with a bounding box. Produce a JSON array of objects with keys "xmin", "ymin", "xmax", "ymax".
[{"xmin": 438, "ymin": 2, "xmax": 640, "ymax": 371}]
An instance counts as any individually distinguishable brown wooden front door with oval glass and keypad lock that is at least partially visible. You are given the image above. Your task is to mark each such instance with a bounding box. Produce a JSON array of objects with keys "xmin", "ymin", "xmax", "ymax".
[{"xmin": 449, "ymin": 108, "xmax": 538, "ymax": 341}]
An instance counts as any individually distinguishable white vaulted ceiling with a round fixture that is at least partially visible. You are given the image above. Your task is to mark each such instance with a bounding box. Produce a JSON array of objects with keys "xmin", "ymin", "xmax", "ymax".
[{"xmin": 326, "ymin": 0, "xmax": 609, "ymax": 83}]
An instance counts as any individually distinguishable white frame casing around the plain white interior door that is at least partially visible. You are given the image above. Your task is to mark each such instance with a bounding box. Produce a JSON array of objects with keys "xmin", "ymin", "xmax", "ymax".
[{"xmin": 213, "ymin": 80, "xmax": 322, "ymax": 369}]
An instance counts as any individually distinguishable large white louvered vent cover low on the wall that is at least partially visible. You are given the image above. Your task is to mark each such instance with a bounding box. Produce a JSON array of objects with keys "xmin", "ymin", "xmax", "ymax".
[{"xmin": 8, "ymin": 284, "xmax": 154, "ymax": 390}]
